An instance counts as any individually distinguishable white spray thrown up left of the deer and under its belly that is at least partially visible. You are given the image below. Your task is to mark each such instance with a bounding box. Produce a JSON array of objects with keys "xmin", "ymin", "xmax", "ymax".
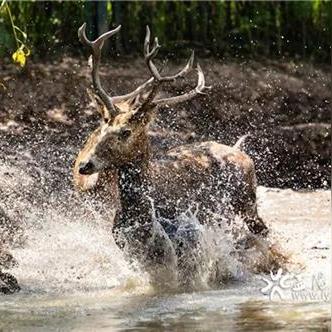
[{"xmin": 0, "ymin": 139, "xmax": 286, "ymax": 292}]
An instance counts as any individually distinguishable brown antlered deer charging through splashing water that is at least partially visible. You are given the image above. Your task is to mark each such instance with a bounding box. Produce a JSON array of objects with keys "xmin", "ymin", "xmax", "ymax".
[{"xmin": 73, "ymin": 23, "xmax": 282, "ymax": 288}]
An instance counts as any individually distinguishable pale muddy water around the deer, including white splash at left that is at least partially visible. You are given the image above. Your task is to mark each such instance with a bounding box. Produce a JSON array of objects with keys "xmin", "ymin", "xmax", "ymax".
[{"xmin": 0, "ymin": 187, "xmax": 331, "ymax": 331}]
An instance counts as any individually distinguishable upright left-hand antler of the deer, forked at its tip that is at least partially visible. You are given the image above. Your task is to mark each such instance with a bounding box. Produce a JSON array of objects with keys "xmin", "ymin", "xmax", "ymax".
[{"xmin": 78, "ymin": 23, "xmax": 121, "ymax": 116}]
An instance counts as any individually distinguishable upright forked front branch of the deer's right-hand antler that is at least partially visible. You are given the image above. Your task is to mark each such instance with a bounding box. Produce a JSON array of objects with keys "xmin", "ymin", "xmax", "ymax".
[{"xmin": 144, "ymin": 26, "xmax": 194, "ymax": 83}]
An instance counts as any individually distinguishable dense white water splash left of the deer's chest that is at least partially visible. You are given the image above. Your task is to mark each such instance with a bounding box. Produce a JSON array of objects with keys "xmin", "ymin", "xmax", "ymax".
[{"xmin": 12, "ymin": 213, "xmax": 145, "ymax": 291}]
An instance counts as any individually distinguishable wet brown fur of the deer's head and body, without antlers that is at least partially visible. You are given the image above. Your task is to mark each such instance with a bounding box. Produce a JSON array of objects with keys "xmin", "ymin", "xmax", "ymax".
[{"xmin": 74, "ymin": 98, "xmax": 281, "ymax": 278}]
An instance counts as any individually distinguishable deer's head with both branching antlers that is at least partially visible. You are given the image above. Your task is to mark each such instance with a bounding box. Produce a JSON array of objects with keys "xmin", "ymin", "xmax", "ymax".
[{"xmin": 78, "ymin": 23, "xmax": 206, "ymax": 175}]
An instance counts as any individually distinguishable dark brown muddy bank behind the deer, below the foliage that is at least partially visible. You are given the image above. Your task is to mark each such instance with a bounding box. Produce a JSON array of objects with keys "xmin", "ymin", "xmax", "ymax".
[{"xmin": 0, "ymin": 58, "xmax": 331, "ymax": 189}]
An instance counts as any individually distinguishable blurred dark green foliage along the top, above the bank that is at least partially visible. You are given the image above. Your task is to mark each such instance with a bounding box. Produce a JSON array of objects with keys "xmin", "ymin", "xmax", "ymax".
[{"xmin": 0, "ymin": 0, "xmax": 332, "ymax": 62}]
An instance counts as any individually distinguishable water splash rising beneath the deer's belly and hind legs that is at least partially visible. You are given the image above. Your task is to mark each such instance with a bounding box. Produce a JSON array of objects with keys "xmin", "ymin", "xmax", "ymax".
[{"xmin": 127, "ymin": 200, "xmax": 260, "ymax": 291}]
